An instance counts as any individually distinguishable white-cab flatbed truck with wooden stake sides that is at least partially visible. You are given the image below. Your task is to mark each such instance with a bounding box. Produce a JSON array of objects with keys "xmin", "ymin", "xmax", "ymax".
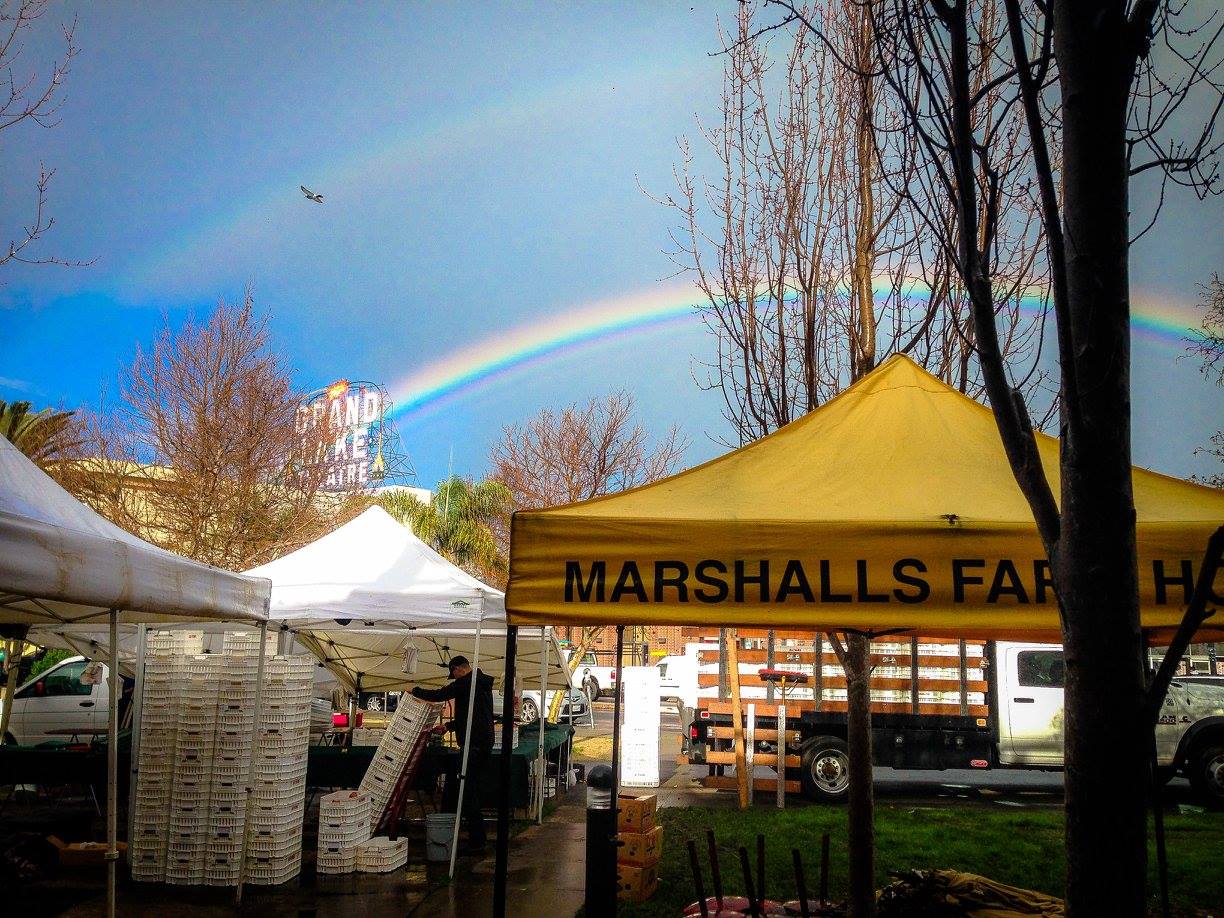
[{"xmin": 690, "ymin": 641, "xmax": 1224, "ymax": 807}]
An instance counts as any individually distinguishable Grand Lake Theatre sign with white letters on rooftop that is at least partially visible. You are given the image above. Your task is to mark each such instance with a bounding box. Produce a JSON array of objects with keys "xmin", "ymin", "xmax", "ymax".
[{"xmin": 297, "ymin": 379, "xmax": 408, "ymax": 491}]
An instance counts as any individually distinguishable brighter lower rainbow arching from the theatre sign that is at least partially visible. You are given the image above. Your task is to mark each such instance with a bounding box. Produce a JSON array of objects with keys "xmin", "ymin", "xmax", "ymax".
[{"xmin": 389, "ymin": 279, "xmax": 1197, "ymax": 421}]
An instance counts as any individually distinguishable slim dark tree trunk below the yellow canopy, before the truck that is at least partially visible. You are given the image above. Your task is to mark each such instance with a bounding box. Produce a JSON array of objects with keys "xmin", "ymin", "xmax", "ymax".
[{"xmin": 845, "ymin": 634, "xmax": 875, "ymax": 918}]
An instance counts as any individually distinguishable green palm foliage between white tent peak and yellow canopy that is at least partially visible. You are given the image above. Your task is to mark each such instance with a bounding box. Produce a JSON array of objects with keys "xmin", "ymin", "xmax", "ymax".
[{"xmin": 375, "ymin": 476, "xmax": 514, "ymax": 585}]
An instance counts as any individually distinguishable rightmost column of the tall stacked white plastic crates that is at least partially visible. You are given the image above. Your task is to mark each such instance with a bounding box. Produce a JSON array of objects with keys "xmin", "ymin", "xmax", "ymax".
[{"xmin": 246, "ymin": 656, "xmax": 315, "ymax": 885}]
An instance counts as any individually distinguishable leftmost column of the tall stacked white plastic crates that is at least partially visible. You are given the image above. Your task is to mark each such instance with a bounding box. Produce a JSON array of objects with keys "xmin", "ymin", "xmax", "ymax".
[{"xmin": 127, "ymin": 630, "xmax": 203, "ymax": 881}]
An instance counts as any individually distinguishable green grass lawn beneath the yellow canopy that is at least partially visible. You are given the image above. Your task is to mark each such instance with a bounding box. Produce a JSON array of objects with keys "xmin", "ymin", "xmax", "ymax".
[{"xmin": 618, "ymin": 802, "xmax": 1224, "ymax": 916}]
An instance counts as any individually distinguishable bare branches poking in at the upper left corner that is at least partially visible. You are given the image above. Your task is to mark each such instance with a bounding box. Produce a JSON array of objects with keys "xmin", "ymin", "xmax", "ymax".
[{"xmin": 0, "ymin": 0, "xmax": 89, "ymax": 267}]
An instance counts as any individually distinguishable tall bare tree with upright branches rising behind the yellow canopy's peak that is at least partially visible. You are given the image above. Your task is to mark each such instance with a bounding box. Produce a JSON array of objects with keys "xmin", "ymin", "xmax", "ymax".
[{"xmin": 662, "ymin": 7, "xmax": 1048, "ymax": 916}]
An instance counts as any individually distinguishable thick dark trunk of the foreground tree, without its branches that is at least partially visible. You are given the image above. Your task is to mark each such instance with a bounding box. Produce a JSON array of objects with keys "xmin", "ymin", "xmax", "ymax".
[{"xmin": 1051, "ymin": 0, "xmax": 1149, "ymax": 917}]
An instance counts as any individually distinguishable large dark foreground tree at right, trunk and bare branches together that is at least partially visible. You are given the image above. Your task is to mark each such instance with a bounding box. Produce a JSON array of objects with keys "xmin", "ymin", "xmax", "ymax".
[{"xmin": 749, "ymin": 0, "xmax": 1224, "ymax": 916}]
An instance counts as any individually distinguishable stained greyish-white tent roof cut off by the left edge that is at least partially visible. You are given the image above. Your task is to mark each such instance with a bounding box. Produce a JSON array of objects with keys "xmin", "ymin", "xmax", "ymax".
[{"xmin": 0, "ymin": 437, "xmax": 268, "ymax": 627}]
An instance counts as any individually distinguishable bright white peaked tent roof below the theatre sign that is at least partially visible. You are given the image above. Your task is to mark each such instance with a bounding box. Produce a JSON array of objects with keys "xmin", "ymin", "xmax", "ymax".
[{"xmin": 246, "ymin": 507, "xmax": 496, "ymax": 630}]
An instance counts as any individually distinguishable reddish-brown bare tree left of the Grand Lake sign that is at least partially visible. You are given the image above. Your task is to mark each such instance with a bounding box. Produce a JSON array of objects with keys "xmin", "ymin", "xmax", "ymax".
[{"xmin": 70, "ymin": 293, "xmax": 368, "ymax": 570}]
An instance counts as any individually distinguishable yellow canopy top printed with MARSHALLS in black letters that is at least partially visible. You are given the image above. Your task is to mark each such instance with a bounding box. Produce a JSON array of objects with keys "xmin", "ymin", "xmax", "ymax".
[{"xmin": 506, "ymin": 356, "xmax": 1224, "ymax": 641}]
